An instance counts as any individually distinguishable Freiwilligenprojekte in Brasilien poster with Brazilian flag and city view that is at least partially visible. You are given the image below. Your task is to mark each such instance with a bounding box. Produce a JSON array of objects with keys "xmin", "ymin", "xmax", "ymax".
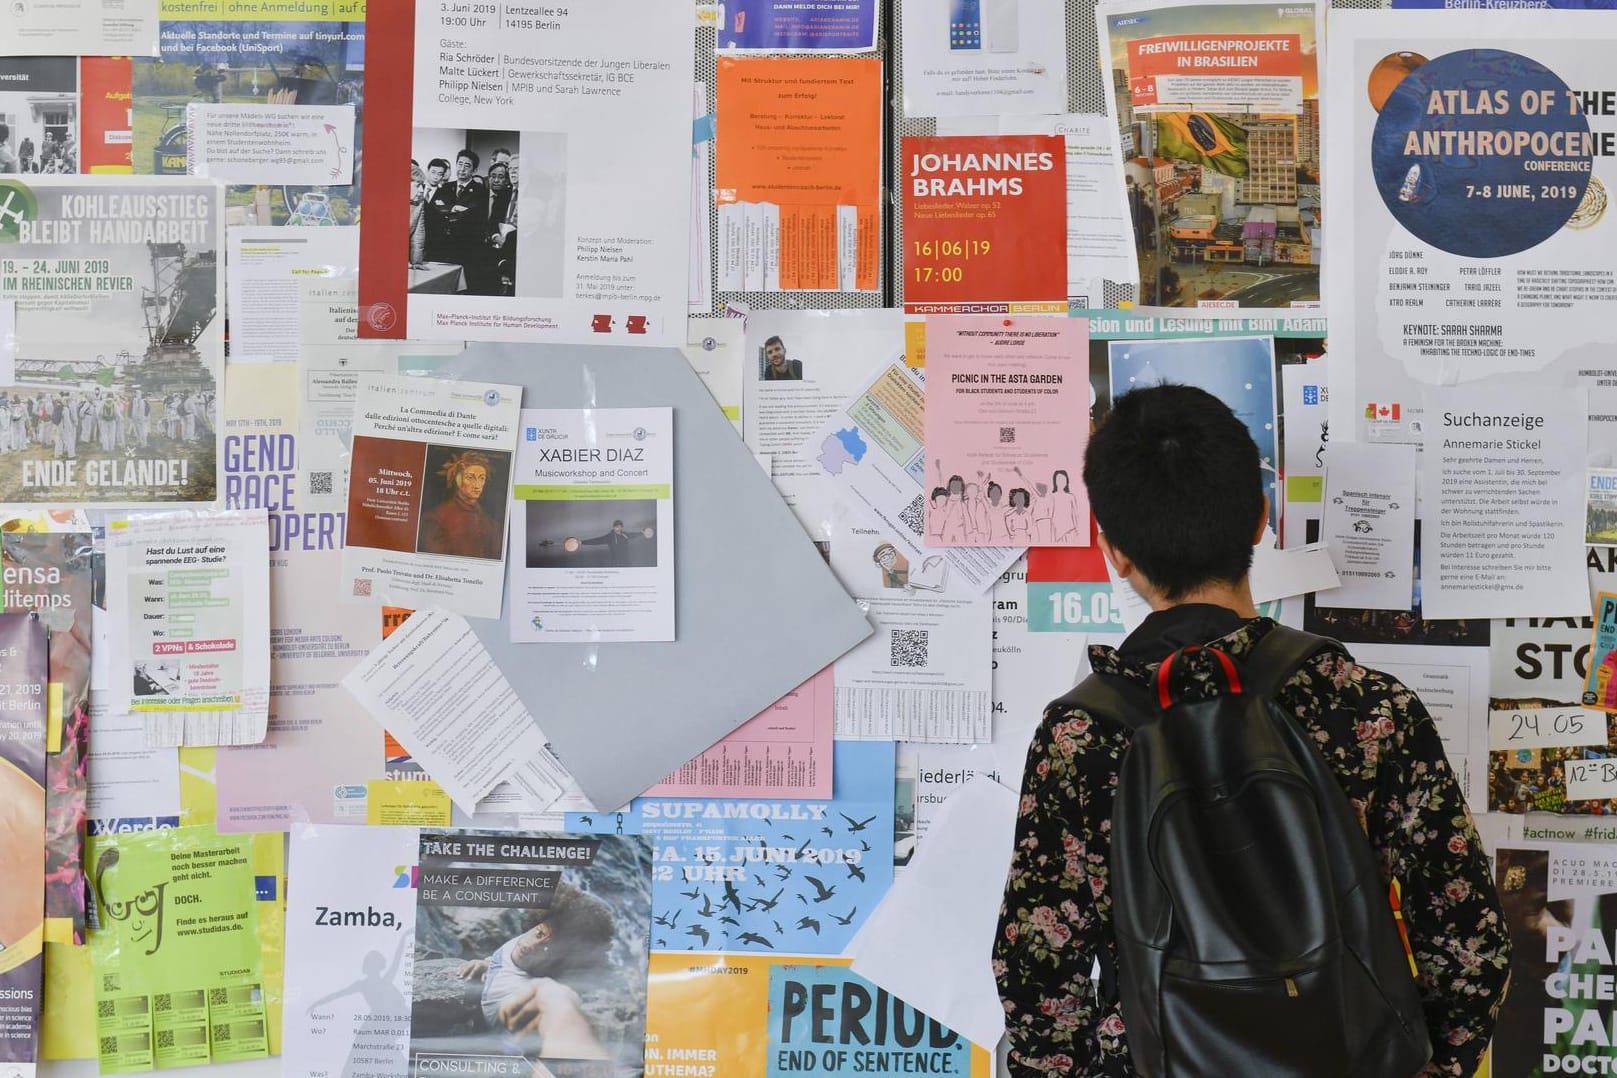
[{"xmin": 1096, "ymin": 0, "xmax": 1325, "ymax": 311}]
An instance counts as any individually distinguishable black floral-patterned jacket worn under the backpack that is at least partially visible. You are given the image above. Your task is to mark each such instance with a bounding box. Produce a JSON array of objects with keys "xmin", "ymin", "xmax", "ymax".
[{"xmin": 993, "ymin": 604, "xmax": 1510, "ymax": 1078}]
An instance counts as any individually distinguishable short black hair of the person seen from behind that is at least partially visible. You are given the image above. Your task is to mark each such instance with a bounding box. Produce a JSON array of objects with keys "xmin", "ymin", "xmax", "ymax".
[{"xmin": 1083, "ymin": 383, "xmax": 1263, "ymax": 601}]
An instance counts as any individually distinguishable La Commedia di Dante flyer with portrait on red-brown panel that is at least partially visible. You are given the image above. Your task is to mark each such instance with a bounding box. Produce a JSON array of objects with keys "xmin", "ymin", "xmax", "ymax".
[{"xmin": 343, "ymin": 373, "xmax": 522, "ymax": 617}]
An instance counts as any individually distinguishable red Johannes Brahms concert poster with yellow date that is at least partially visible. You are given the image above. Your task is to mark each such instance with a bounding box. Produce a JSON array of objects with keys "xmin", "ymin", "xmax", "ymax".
[{"xmin": 902, "ymin": 134, "xmax": 1067, "ymax": 314}]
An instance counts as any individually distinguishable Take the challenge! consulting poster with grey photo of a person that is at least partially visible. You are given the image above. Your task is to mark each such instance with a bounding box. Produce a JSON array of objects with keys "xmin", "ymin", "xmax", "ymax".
[{"xmin": 409, "ymin": 831, "xmax": 652, "ymax": 1078}]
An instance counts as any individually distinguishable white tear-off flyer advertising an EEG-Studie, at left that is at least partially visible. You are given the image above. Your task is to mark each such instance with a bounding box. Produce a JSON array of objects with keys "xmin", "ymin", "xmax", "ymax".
[{"xmin": 107, "ymin": 509, "xmax": 270, "ymax": 747}]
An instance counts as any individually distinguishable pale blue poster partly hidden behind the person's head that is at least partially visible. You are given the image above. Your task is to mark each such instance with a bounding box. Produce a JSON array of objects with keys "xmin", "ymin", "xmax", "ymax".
[{"xmin": 1108, "ymin": 336, "xmax": 1281, "ymax": 535}]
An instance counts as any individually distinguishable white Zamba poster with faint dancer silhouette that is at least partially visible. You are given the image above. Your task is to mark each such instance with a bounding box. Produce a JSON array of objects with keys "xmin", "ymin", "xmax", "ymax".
[{"xmin": 281, "ymin": 824, "xmax": 420, "ymax": 1078}]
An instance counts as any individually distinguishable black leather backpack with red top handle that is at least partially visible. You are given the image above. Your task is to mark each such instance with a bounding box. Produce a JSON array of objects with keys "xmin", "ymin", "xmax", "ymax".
[{"xmin": 1062, "ymin": 625, "xmax": 1431, "ymax": 1078}]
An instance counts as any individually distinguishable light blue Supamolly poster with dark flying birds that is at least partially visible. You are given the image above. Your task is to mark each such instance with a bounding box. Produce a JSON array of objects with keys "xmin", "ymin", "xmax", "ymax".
[{"xmin": 566, "ymin": 740, "xmax": 894, "ymax": 955}]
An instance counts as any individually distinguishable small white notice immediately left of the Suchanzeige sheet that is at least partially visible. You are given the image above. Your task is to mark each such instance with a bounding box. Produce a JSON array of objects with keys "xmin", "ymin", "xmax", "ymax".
[{"xmin": 1315, "ymin": 441, "xmax": 1416, "ymax": 611}]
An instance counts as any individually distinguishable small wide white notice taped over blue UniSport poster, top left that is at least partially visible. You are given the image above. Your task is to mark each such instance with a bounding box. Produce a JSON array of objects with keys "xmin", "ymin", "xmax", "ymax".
[{"xmin": 186, "ymin": 102, "xmax": 354, "ymax": 187}]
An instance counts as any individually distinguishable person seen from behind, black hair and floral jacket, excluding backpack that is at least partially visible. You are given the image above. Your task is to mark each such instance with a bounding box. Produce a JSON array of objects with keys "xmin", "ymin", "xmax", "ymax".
[{"xmin": 993, "ymin": 385, "xmax": 1510, "ymax": 1078}]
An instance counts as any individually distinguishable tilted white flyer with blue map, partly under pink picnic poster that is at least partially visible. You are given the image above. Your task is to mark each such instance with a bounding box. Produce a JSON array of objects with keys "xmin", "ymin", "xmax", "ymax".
[{"xmin": 802, "ymin": 359, "xmax": 1022, "ymax": 598}]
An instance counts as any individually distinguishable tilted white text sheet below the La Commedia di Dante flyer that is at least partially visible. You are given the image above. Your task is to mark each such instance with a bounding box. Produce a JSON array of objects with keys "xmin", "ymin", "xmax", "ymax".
[{"xmin": 343, "ymin": 611, "xmax": 561, "ymax": 811}]
